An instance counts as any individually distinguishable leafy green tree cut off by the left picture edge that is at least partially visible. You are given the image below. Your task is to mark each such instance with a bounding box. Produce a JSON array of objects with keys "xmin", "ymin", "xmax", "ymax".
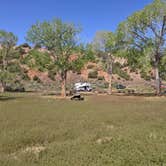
[{"xmin": 0, "ymin": 30, "xmax": 17, "ymax": 92}]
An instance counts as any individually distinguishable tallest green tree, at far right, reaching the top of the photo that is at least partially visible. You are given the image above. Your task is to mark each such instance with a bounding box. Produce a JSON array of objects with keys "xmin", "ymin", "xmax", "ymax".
[{"xmin": 118, "ymin": 0, "xmax": 166, "ymax": 95}]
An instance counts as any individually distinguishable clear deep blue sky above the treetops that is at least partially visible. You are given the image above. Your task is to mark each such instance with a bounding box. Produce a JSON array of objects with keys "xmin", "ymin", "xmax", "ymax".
[{"xmin": 0, "ymin": 0, "xmax": 152, "ymax": 44}]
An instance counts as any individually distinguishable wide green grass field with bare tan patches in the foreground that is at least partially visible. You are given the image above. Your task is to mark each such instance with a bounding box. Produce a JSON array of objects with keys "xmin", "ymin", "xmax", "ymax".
[{"xmin": 0, "ymin": 94, "xmax": 166, "ymax": 166}]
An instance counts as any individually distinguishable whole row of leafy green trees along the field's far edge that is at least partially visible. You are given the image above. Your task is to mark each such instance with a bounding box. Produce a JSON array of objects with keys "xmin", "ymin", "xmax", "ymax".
[{"xmin": 0, "ymin": 0, "xmax": 166, "ymax": 97}]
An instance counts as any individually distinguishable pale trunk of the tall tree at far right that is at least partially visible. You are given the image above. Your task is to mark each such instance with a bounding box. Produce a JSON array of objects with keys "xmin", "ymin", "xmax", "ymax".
[{"xmin": 154, "ymin": 63, "xmax": 161, "ymax": 95}]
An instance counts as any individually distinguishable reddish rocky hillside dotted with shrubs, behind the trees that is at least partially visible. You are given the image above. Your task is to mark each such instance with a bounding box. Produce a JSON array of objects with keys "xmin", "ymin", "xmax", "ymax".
[{"xmin": 13, "ymin": 45, "xmax": 154, "ymax": 92}]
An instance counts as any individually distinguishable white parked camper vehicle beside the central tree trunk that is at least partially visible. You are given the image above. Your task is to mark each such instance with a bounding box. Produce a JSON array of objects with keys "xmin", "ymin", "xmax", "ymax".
[{"xmin": 74, "ymin": 82, "xmax": 92, "ymax": 92}]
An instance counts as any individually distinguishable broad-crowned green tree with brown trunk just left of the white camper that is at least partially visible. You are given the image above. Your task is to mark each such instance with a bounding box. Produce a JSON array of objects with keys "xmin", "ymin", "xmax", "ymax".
[{"xmin": 27, "ymin": 19, "xmax": 89, "ymax": 97}]
